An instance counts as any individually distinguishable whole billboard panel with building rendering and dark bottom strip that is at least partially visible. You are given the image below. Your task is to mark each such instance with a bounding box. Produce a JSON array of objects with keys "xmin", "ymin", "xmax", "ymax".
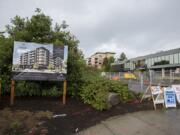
[{"xmin": 12, "ymin": 42, "xmax": 68, "ymax": 81}]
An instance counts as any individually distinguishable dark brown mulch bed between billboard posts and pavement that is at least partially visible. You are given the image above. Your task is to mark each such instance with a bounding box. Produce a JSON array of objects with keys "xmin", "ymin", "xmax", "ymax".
[{"xmin": 0, "ymin": 97, "xmax": 153, "ymax": 135}]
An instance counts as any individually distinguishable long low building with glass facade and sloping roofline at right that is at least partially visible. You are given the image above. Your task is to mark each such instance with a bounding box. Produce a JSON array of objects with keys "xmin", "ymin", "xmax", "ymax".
[{"xmin": 112, "ymin": 48, "xmax": 180, "ymax": 71}]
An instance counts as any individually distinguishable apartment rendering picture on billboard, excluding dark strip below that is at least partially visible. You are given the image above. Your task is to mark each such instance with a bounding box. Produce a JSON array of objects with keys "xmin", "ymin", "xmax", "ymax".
[{"xmin": 12, "ymin": 42, "xmax": 68, "ymax": 73}]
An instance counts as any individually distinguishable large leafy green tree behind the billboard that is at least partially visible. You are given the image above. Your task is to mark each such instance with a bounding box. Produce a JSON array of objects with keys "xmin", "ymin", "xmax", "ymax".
[{"xmin": 0, "ymin": 9, "xmax": 85, "ymax": 95}]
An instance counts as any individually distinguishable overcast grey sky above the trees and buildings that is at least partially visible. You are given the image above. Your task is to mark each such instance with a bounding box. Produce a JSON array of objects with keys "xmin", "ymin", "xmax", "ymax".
[{"xmin": 0, "ymin": 0, "xmax": 180, "ymax": 58}]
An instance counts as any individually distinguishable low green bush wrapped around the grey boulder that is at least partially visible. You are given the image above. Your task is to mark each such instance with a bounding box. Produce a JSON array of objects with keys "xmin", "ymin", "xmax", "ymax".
[{"xmin": 80, "ymin": 70, "xmax": 133, "ymax": 110}]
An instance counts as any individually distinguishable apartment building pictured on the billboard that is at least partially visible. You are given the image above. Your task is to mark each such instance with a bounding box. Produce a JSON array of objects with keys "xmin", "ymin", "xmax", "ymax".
[{"xmin": 20, "ymin": 47, "xmax": 51, "ymax": 69}]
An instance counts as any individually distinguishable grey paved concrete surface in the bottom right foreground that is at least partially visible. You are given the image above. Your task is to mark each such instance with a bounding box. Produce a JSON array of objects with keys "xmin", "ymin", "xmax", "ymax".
[{"xmin": 78, "ymin": 109, "xmax": 180, "ymax": 135}]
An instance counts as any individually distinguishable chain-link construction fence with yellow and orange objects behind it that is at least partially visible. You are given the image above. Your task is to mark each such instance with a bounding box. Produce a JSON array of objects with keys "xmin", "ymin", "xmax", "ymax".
[{"xmin": 102, "ymin": 70, "xmax": 180, "ymax": 93}]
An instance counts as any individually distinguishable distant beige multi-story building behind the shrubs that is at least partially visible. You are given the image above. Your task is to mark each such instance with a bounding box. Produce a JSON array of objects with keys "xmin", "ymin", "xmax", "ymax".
[{"xmin": 87, "ymin": 52, "xmax": 115, "ymax": 69}]
